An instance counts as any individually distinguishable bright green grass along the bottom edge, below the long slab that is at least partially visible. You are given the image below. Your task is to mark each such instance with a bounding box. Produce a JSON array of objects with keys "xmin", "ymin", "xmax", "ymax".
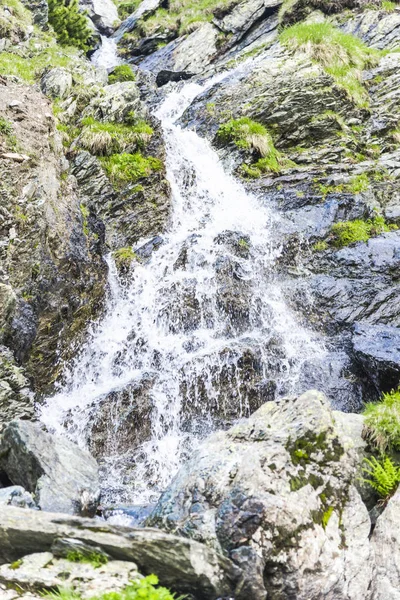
[{"xmin": 44, "ymin": 575, "xmax": 185, "ymax": 600}]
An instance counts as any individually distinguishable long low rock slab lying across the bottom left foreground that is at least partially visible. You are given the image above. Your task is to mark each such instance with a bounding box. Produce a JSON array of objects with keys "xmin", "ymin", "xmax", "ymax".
[{"xmin": 0, "ymin": 507, "xmax": 240, "ymax": 600}]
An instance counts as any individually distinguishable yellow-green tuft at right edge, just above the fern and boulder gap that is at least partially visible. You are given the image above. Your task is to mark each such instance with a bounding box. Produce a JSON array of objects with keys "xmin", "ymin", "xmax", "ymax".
[{"xmin": 363, "ymin": 388, "xmax": 400, "ymax": 452}]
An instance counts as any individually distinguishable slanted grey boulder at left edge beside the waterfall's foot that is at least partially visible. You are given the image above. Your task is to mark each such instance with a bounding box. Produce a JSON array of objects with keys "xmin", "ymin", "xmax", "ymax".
[{"xmin": 0, "ymin": 421, "xmax": 99, "ymax": 514}]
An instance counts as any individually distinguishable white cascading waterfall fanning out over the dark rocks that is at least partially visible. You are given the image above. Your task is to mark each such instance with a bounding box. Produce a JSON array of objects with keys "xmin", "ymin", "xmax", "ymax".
[{"xmin": 42, "ymin": 57, "xmax": 354, "ymax": 504}]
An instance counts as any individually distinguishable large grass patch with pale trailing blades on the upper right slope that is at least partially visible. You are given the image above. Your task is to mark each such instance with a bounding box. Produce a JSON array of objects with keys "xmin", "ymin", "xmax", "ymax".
[{"xmin": 280, "ymin": 21, "xmax": 379, "ymax": 107}]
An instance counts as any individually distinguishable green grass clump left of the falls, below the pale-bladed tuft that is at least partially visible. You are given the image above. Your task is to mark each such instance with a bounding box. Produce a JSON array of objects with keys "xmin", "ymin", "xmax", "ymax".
[{"xmin": 100, "ymin": 152, "xmax": 163, "ymax": 187}]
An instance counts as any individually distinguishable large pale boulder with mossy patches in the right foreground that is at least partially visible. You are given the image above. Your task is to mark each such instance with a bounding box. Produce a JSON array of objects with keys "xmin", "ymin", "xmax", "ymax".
[{"xmin": 149, "ymin": 392, "xmax": 372, "ymax": 600}]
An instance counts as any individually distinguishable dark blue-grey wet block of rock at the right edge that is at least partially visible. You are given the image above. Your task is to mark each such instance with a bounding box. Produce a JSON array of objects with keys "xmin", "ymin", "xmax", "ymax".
[{"xmin": 352, "ymin": 322, "xmax": 400, "ymax": 391}]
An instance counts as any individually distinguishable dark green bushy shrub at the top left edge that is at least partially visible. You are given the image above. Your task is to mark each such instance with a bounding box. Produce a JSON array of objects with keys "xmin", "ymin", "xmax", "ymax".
[{"xmin": 48, "ymin": 0, "xmax": 92, "ymax": 50}]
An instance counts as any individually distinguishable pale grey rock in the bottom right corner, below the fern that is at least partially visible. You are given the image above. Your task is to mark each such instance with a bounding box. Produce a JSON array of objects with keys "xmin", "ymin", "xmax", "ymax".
[{"xmin": 371, "ymin": 488, "xmax": 400, "ymax": 600}]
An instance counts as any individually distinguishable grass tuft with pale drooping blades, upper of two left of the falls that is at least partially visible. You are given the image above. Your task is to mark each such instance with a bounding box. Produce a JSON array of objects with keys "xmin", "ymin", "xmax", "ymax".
[{"xmin": 77, "ymin": 117, "xmax": 154, "ymax": 156}]
